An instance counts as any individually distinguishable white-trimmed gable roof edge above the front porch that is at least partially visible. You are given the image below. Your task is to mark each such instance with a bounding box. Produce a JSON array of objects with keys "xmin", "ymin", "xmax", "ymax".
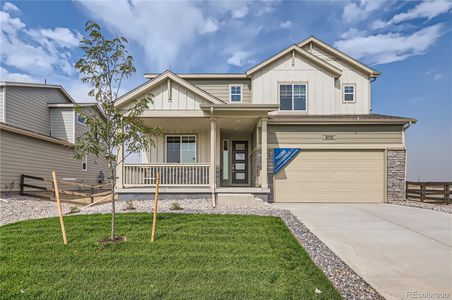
[{"xmin": 115, "ymin": 70, "xmax": 225, "ymax": 106}]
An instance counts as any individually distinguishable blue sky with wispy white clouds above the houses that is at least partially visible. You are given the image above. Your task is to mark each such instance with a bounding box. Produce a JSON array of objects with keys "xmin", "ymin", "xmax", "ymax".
[{"xmin": 0, "ymin": 0, "xmax": 452, "ymax": 181}]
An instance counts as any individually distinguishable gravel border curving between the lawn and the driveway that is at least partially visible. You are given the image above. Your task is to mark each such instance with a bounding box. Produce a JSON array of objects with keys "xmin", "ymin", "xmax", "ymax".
[{"xmin": 0, "ymin": 198, "xmax": 384, "ymax": 299}]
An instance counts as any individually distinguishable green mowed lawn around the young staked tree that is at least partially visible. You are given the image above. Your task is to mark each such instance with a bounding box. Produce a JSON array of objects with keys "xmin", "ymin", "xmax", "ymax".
[{"xmin": 0, "ymin": 213, "xmax": 340, "ymax": 299}]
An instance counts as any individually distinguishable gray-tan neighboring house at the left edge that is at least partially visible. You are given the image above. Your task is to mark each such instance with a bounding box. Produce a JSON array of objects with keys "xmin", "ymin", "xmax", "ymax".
[{"xmin": 0, "ymin": 82, "xmax": 108, "ymax": 192}]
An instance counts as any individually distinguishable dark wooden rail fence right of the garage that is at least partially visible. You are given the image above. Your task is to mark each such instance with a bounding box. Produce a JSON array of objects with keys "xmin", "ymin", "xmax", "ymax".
[{"xmin": 406, "ymin": 181, "xmax": 452, "ymax": 204}]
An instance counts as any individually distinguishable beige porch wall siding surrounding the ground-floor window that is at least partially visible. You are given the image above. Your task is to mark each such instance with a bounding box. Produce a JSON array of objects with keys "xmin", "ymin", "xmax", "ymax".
[{"xmin": 141, "ymin": 128, "xmax": 210, "ymax": 163}]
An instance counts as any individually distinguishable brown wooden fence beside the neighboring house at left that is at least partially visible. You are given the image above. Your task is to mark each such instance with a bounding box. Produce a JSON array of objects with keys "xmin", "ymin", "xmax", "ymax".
[{"xmin": 20, "ymin": 174, "xmax": 111, "ymax": 205}]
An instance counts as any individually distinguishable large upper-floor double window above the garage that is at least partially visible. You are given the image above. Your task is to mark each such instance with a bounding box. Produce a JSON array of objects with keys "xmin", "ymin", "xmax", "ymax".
[{"xmin": 279, "ymin": 84, "xmax": 307, "ymax": 111}]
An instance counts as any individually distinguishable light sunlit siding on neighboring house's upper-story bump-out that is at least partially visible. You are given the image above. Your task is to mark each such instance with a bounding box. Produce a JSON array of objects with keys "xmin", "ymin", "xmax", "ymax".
[{"xmin": 50, "ymin": 107, "xmax": 75, "ymax": 143}]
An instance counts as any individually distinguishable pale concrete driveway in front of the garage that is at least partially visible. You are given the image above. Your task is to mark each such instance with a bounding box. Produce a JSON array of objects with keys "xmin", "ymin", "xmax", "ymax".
[{"xmin": 275, "ymin": 203, "xmax": 452, "ymax": 299}]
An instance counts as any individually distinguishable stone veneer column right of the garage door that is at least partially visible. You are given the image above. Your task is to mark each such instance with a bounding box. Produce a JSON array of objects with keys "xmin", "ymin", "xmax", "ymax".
[{"xmin": 387, "ymin": 150, "xmax": 406, "ymax": 202}]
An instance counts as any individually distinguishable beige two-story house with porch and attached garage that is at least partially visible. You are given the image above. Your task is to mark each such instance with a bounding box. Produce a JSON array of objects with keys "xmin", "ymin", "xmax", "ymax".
[{"xmin": 116, "ymin": 37, "xmax": 416, "ymax": 202}]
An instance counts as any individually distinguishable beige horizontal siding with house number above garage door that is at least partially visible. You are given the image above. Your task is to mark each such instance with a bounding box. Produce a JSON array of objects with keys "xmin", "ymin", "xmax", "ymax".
[{"xmin": 268, "ymin": 125, "xmax": 403, "ymax": 147}]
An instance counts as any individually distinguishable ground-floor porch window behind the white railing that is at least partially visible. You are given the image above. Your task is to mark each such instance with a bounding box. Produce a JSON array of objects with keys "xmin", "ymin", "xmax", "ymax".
[{"xmin": 166, "ymin": 135, "xmax": 196, "ymax": 163}]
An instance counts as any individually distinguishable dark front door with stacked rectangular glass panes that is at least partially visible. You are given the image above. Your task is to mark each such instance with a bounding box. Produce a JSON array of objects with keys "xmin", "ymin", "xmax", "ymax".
[{"xmin": 231, "ymin": 141, "xmax": 248, "ymax": 184}]
